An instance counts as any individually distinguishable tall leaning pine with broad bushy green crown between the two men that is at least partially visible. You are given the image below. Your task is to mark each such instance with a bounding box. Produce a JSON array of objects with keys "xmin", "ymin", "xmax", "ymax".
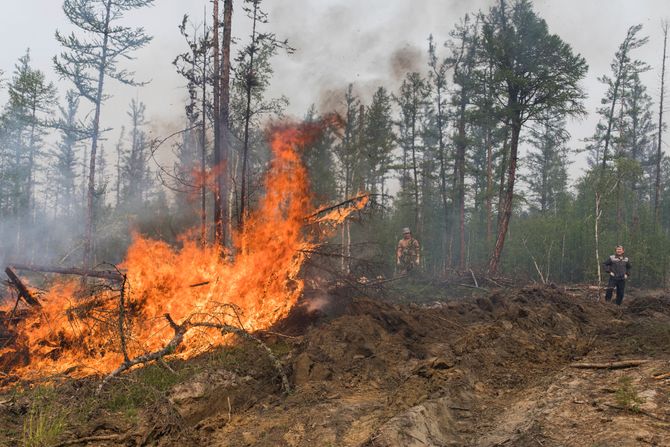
[{"xmin": 483, "ymin": 0, "xmax": 587, "ymax": 272}]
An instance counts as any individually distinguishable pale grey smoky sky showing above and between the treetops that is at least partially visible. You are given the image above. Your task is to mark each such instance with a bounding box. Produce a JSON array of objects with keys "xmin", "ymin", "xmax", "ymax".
[{"xmin": 0, "ymin": 0, "xmax": 670, "ymax": 181}]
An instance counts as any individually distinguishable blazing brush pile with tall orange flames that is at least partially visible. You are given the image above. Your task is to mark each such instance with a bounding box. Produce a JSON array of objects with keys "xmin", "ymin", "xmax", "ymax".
[{"xmin": 0, "ymin": 127, "xmax": 367, "ymax": 383}]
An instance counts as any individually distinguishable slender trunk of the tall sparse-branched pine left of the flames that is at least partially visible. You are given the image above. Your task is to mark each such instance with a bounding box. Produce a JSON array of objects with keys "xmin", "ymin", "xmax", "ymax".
[{"xmin": 83, "ymin": 0, "xmax": 112, "ymax": 268}]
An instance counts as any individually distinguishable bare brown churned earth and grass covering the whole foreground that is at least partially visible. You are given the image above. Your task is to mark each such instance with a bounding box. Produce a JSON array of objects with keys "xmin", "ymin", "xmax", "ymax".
[{"xmin": 0, "ymin": 286, "xmax": 670, "ymax": 447}]
